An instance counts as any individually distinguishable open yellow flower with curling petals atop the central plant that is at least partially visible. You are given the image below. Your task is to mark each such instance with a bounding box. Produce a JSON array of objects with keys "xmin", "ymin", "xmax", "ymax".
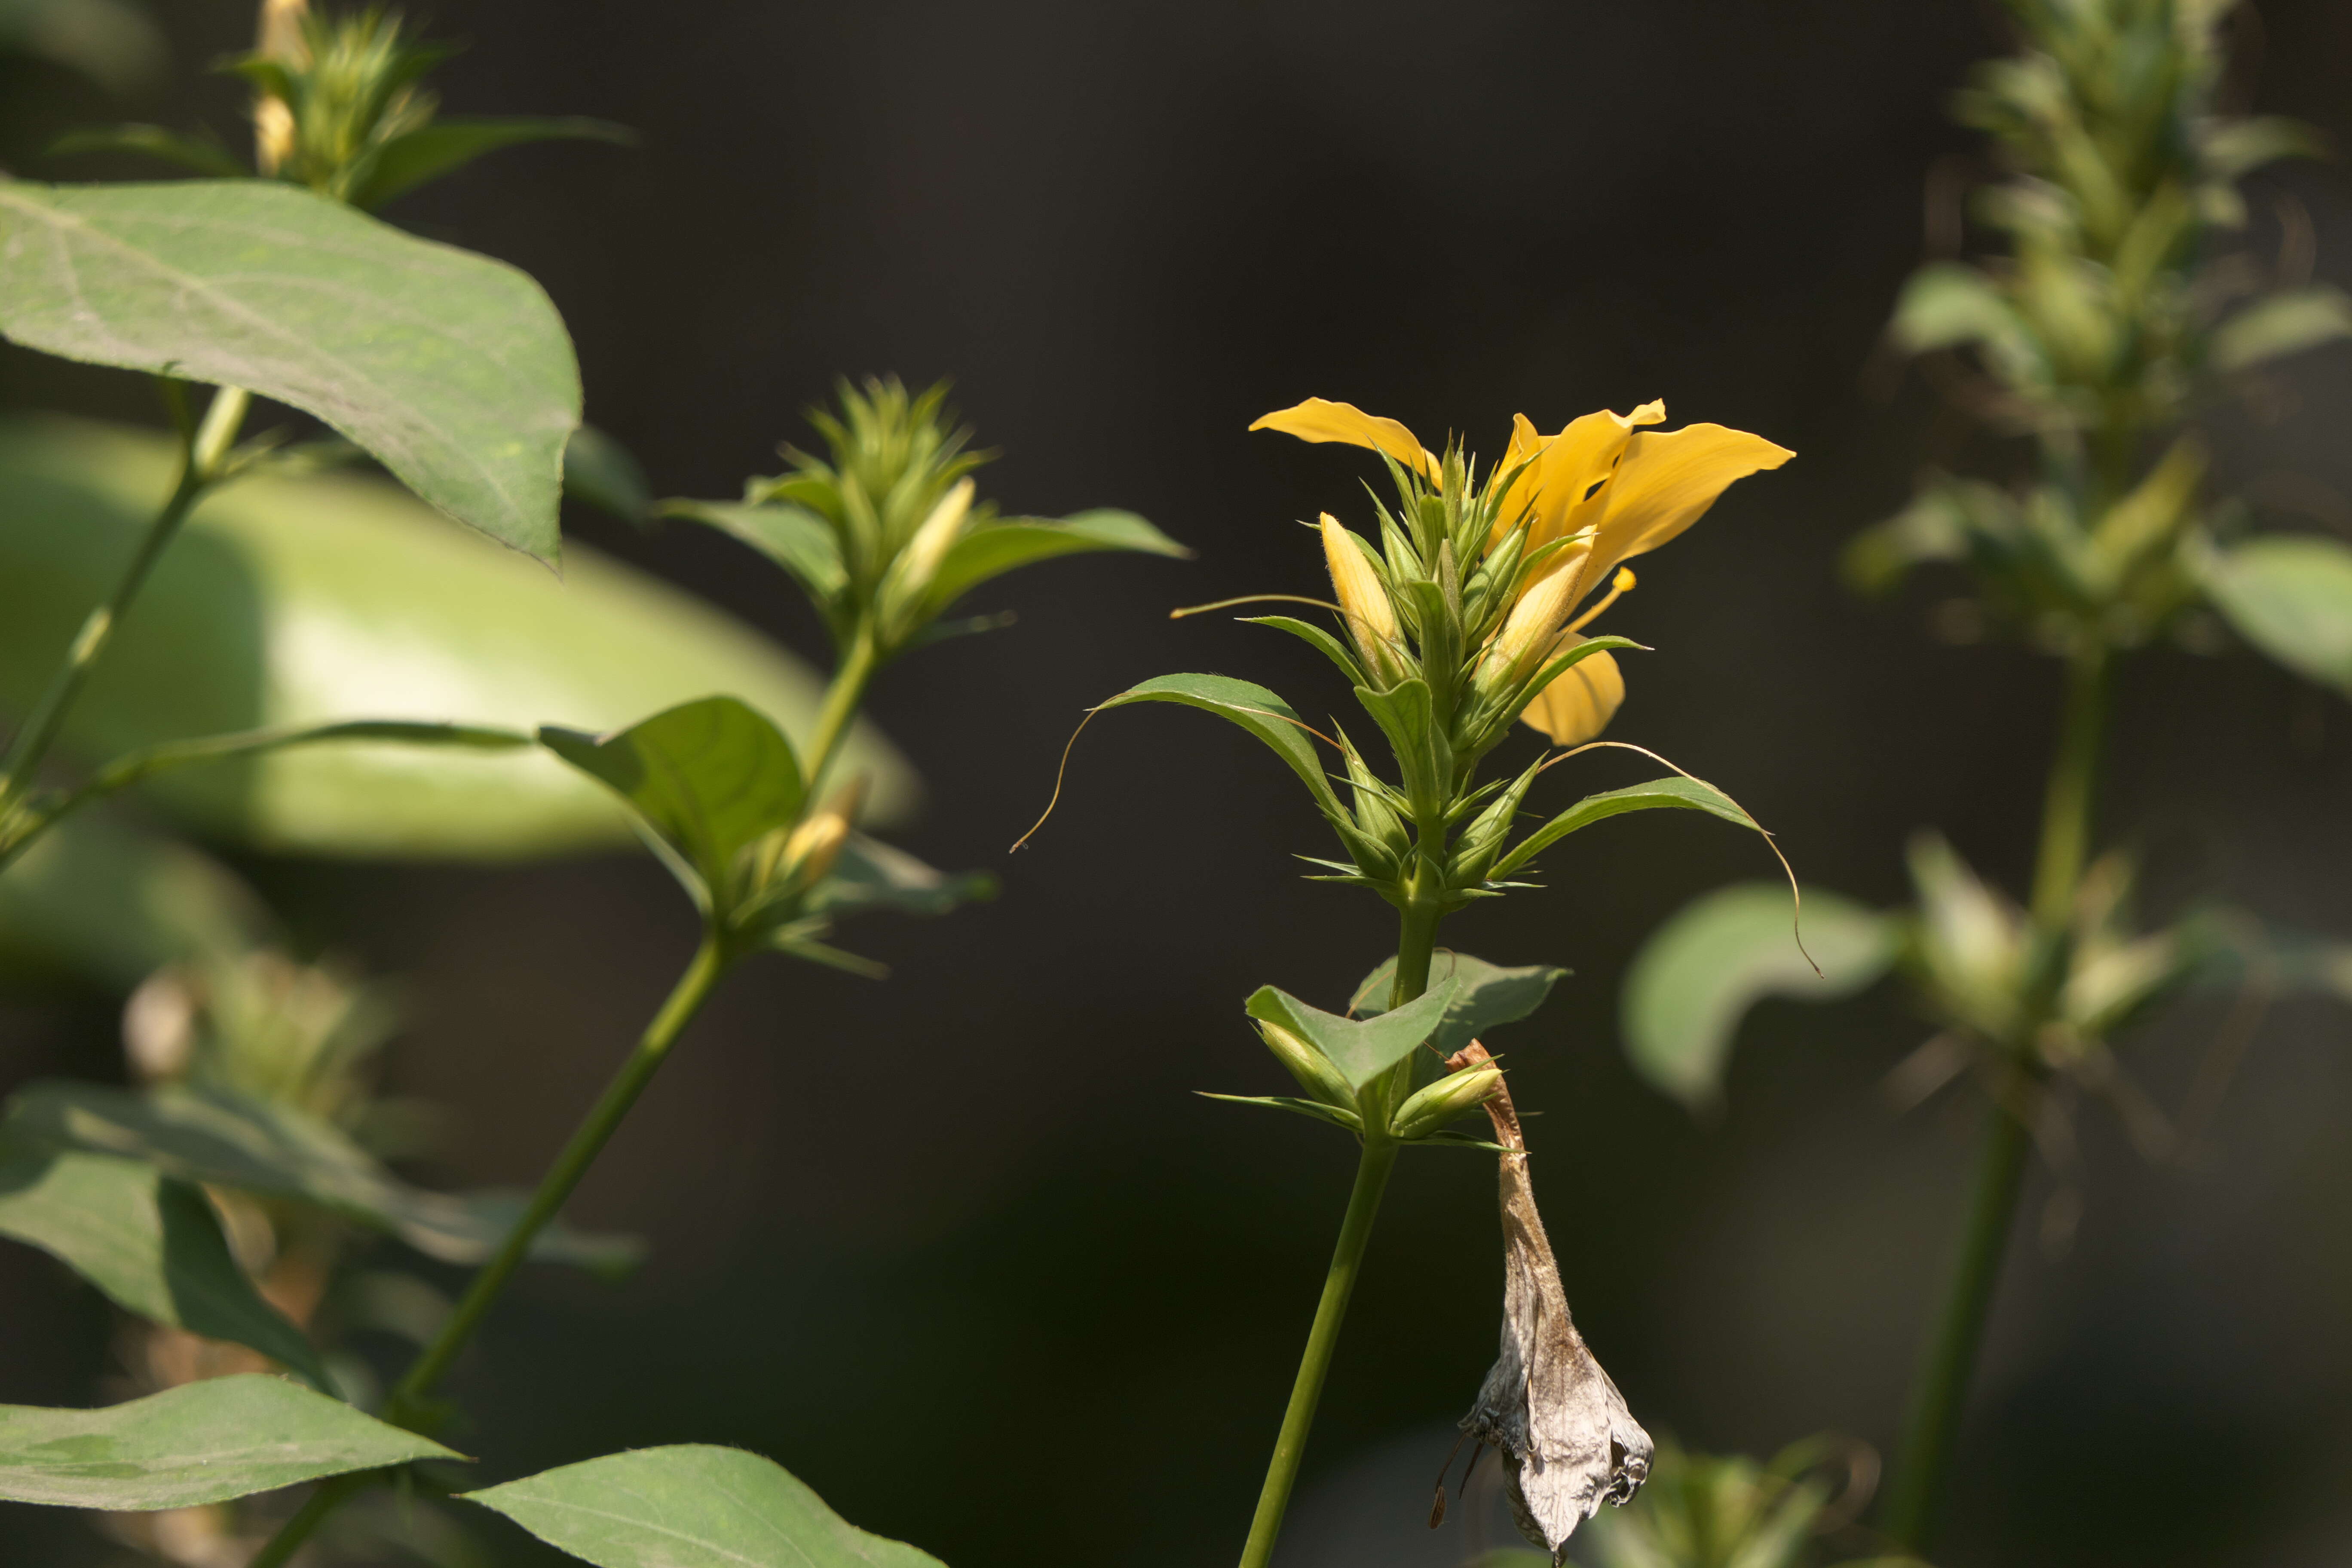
[{"xmin": 1249, "ymin": 397, "xmax": 1797, "ymax": 745}]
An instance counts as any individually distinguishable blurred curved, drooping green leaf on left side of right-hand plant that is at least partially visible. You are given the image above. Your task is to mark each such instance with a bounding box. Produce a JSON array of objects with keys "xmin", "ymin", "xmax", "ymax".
[{"xmin": 1623, "ymin": 882, "xmax": 1898, "ymax": 1109}]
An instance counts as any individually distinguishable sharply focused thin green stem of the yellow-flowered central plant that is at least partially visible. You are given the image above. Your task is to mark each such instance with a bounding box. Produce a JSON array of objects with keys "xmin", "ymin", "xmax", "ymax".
[{"xmin": 1242, "ymin": 903, "xmax": 1437, "ymax": 1568}]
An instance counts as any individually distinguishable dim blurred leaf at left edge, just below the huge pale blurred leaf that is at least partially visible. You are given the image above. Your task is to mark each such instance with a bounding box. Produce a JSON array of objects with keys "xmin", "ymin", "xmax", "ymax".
[{"xmin": 0, "ymin": 816, "xmax": 275, "ymax": 994}]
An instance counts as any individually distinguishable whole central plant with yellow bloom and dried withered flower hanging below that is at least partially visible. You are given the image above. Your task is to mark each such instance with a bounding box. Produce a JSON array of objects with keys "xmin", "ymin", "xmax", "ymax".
[{"xmin": 1030, "ymin": 397, "xmax": 1790, "ymax": 1568}]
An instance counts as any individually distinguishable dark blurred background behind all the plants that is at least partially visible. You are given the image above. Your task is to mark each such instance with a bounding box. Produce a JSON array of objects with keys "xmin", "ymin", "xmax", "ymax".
[{"xmin": 0, "ymin": 0, "xmax": 2352, "ymax": 1568}]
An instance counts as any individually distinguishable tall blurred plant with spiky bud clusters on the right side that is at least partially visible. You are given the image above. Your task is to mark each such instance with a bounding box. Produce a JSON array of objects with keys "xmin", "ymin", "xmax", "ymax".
[{"xmin": 1625, "ymin": 0, "xmax": 2352, "ymax": 1552}]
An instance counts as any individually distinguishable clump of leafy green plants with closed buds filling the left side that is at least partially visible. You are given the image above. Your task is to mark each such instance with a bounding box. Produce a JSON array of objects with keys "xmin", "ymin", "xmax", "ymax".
[{"xmin": 0, "ymin": 0, "xmax": 1183, "ymax": 1568}]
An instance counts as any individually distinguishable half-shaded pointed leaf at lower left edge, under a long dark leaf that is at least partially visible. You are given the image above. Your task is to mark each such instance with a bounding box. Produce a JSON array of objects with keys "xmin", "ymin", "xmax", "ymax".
[{"xmin": 0, "ymin": 1149, "xmax": 327, "ymax": 1389}]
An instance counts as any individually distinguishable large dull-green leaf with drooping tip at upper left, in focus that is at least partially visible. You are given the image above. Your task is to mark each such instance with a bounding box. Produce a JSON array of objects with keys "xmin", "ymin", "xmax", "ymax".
[{"xmin": 0, "ymin": 179, "xmax": 581, "ymax": 564}]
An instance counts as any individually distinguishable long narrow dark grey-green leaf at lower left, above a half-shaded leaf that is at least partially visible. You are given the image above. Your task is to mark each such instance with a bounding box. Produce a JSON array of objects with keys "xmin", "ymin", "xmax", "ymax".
[{"xmin": 0, "ymin": 1079, "xmax": 637, "ymax": 1272}]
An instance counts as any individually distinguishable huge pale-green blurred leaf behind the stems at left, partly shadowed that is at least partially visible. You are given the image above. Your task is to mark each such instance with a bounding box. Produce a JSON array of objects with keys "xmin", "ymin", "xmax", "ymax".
[{"xmin": 0, "ymin": 419, "xmax": 917, "ymax": 861}]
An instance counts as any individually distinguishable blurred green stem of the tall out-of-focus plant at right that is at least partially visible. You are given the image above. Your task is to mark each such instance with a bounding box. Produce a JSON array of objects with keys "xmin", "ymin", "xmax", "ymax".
[{"xmin": 1884, "ymin": 644, "xmax": 2107, "ymax": 1554}]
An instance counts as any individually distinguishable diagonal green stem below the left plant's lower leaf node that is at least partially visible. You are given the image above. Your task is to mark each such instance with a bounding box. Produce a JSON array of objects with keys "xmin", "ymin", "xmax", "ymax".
[{"xmin": 249, "ymin": 933, "xmax": 729, "ymax": 1568}]
